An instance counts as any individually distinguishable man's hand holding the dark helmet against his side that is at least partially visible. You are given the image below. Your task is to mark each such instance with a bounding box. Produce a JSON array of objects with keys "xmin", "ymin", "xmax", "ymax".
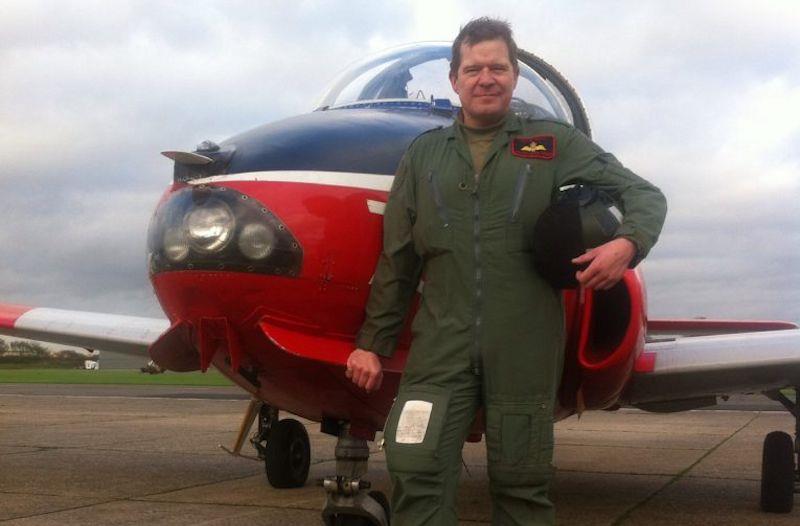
[{"xmin": 572, "ymin": 237, "xmax": 636, "ymax": 290}]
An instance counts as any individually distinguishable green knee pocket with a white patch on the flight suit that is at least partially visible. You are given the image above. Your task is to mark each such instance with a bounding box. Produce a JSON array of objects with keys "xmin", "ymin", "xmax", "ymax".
[{"xmin": 383, "ymin": 386, "xmax": 450, "ymax": 474}]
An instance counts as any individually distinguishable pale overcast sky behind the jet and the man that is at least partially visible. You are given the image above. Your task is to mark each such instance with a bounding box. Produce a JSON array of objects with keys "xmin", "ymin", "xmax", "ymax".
[{"xmin": 0, "ymin": 0, "xmax": 800, "ymax": 322}]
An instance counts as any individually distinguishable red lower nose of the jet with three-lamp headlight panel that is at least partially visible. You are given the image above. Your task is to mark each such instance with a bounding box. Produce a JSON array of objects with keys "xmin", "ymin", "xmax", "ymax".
[{"xmin": 149, "ymin": 179, "xmax": 402, "ymax": 436}]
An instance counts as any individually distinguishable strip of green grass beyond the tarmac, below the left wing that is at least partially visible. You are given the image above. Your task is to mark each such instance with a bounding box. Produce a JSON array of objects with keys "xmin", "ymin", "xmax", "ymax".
[{"xmin": 0, "ymin": 369, "xmax": 233, "ymax": 387}]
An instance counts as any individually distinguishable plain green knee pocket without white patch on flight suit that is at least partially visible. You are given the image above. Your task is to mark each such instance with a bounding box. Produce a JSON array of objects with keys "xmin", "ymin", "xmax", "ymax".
[{"xmin": 486, "ymin": 400, "xmax": 553, "ymax": 486}]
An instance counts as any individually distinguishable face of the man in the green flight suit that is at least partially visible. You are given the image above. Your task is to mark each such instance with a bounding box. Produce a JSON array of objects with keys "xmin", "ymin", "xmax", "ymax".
[{"xmin": 450, "ymin": 39, "xmax": 519, "ymax": 127}]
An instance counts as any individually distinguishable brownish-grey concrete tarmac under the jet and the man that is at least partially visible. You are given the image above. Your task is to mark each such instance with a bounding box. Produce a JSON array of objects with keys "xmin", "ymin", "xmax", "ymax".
[{"xmin": 0, "ymin": 385, "xmax": 800, "ymax": 526}]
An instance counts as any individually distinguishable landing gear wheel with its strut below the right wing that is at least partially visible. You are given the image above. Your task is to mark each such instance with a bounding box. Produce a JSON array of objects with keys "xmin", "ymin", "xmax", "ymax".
[{"xmin": 761, "ymin": 388, "xmax": 800, "ymax": 513}]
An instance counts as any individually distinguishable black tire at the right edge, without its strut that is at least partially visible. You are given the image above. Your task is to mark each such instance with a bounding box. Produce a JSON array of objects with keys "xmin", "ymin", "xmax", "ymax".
[{"xmin": 761, "ymin": 431, "xmax": 795, "ymax": 513}]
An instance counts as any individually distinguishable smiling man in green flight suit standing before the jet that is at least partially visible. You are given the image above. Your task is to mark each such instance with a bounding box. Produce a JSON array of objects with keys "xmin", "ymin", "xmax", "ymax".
[{"xmin": 347, "ymin": 18, "xmax": 666, "ymax": 526}]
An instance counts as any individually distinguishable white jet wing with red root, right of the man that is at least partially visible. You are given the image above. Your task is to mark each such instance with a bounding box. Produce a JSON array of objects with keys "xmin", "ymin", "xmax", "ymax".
[{"xmin": 626, "ymin": 322, "xmax": 800, "ymax": 406}]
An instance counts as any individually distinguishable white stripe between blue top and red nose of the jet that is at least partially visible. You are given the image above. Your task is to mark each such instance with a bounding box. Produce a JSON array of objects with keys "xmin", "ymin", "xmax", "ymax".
[{"xmin": 189, "ymin": 170, "xmax": 394, "ymax": 192}]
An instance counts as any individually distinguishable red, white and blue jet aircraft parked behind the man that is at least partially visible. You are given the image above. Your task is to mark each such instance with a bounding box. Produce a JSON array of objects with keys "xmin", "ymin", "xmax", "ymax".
[{"xmin": 0, "ymin": 43, "xmax": 800, "ymax": 525}]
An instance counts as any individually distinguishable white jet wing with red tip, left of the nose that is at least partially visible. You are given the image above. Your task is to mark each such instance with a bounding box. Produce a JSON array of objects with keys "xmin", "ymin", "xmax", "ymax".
[{"xmin": 0, "ymin": 304, "xmax": 169, "ymax": 356}]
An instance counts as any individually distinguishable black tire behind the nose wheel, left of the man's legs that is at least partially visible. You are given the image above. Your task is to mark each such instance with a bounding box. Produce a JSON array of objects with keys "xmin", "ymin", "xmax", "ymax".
[{"xmin": 264, "ymin": 418, "xmax": 311, "ymax": 488}]
